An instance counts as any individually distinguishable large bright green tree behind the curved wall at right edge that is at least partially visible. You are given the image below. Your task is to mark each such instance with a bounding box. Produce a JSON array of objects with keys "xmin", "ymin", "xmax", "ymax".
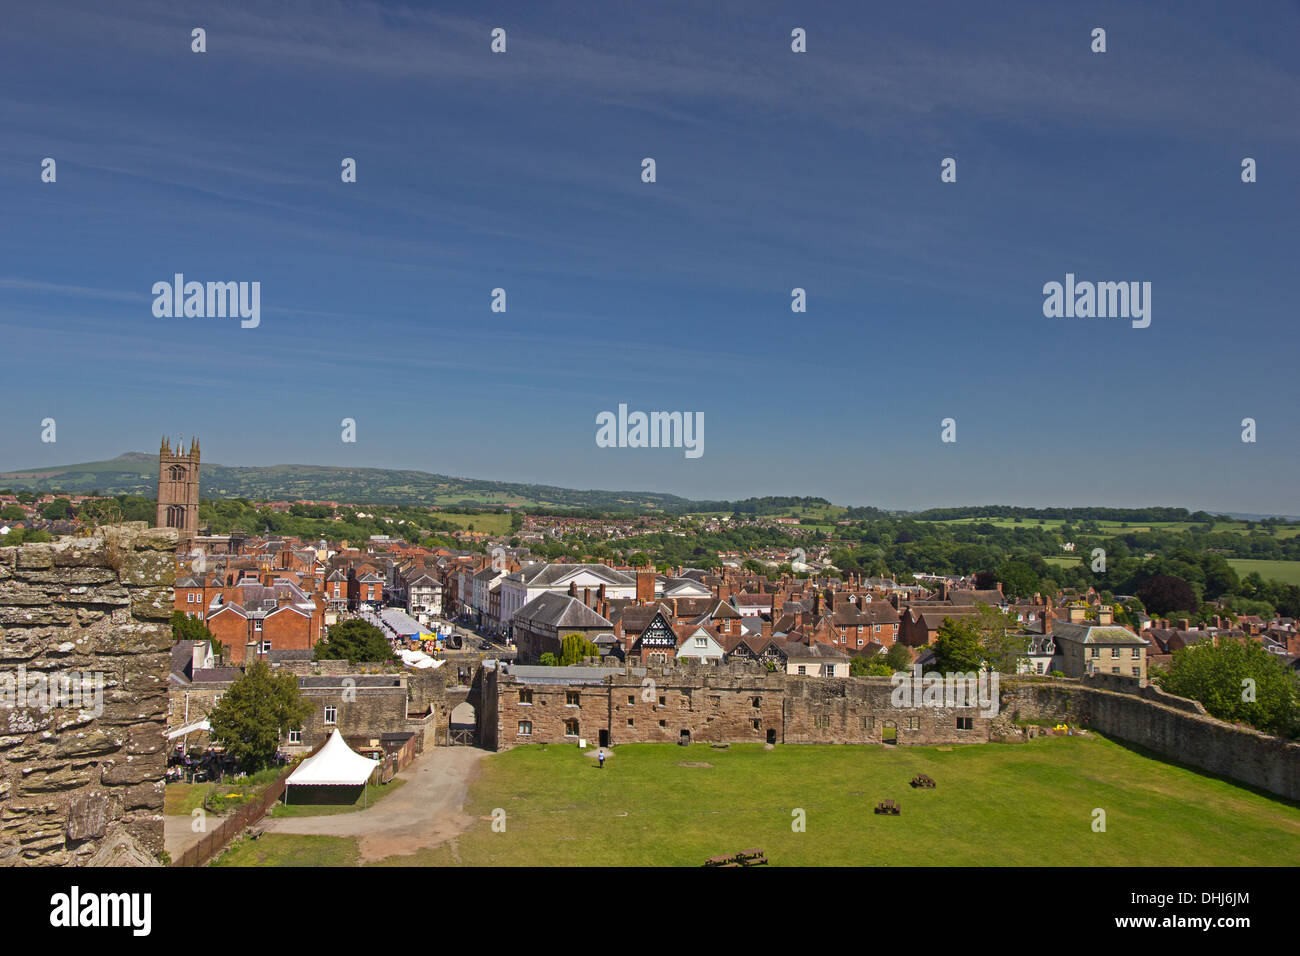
[{"xmin": 1157, "ymin": 640, "xmax": 1300, "ymax": 736}]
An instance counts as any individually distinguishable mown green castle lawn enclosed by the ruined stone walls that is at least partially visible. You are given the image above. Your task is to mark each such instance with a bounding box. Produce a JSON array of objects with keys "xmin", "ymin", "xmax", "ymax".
[{"xmin": 213, "ymin": 736, "xmax": 1300, "ymax": 866}]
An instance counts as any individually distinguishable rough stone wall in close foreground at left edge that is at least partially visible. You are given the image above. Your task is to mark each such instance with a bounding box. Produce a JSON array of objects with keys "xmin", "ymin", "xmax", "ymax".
[{"xmin": 0, "ymin": 522, "xmax": 177, "ymax": 865}]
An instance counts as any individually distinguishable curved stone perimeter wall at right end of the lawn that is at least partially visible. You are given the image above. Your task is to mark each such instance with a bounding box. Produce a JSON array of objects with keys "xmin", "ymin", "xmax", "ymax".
[{"xmin": 1002, "ymin": 680, "xmax": 1300, "ymax": 800}]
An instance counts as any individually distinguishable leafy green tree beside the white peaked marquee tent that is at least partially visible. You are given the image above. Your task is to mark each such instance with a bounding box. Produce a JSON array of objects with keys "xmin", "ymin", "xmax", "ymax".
[{"xmin": 208, "ymin": 661, "xmax": 312, "ymax": 773}]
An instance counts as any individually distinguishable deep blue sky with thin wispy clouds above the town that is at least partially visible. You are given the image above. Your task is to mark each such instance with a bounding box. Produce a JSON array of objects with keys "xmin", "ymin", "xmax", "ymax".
[{"xmin": 0, "ymin": 0, "xmax": 1300, "ymax": 514}]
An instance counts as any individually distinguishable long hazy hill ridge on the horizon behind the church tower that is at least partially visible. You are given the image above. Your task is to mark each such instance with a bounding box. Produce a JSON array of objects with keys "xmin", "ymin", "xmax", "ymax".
[{"xmin": 0, "ymin": 451, "xmax": 728, "ymax": 514}]
